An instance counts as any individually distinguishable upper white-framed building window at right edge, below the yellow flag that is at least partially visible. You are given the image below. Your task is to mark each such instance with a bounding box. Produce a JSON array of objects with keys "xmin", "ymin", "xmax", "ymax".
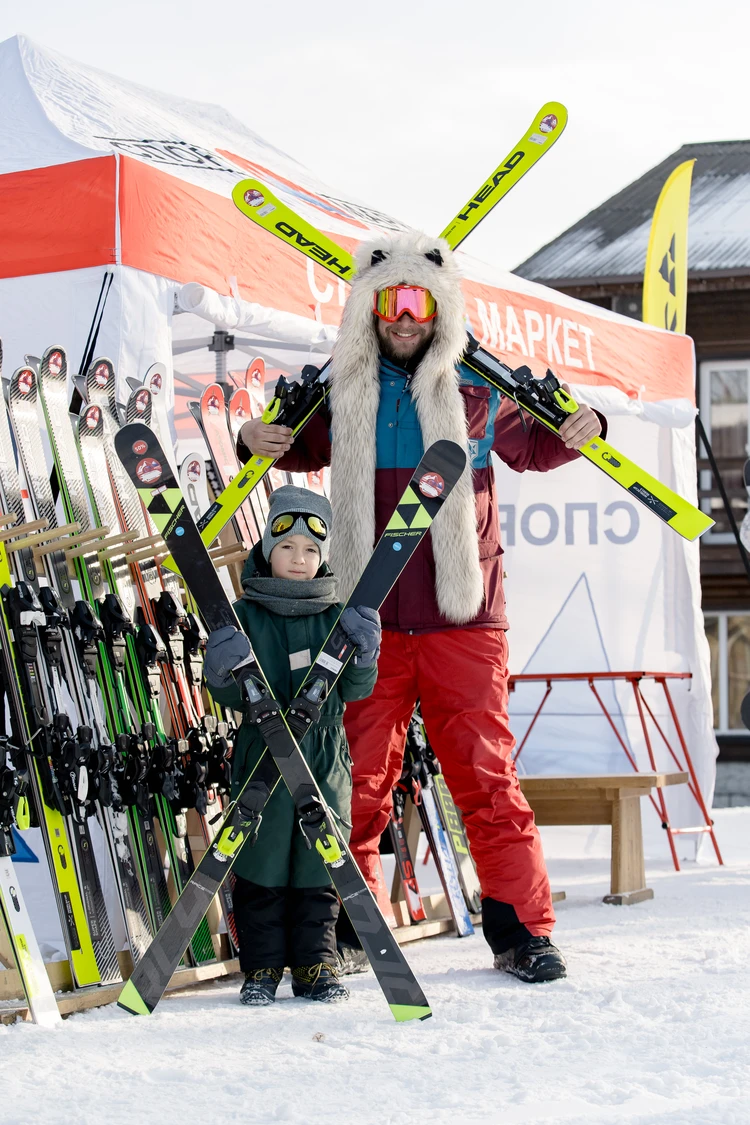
[{"xmin": 698, "ymin": 360, "xmax": 750, "ymax": 543}]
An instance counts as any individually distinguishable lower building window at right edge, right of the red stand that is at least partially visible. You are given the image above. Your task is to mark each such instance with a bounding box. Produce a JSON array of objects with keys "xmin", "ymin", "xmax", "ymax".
[{"xmin": 705, "ymin": 612, "xmax": 750, "ymax": 735}]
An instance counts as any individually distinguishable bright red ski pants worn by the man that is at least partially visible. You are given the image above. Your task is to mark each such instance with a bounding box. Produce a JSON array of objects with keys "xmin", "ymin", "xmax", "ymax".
[{"xmin": 344, "ymin": 629, "xmax": 554, "ymax": 936}]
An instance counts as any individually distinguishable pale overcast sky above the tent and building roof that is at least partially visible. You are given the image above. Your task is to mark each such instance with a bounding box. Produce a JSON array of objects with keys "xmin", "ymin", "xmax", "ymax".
[{"xmin": 0, "ymin": 0, "xmax": 750, "ymax": 269}]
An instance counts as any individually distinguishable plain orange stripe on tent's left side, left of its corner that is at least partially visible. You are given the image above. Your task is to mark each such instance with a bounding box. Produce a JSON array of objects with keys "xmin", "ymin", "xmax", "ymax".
[{"xmin": 0, "ymin": 156, "xmax": 116, "ymax": 278}]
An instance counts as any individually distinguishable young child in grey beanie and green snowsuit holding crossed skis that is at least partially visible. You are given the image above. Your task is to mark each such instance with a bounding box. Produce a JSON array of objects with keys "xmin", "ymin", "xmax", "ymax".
[{"xmin": 204, "ymin": 485, "xmax": 380, "ymax": 1006}]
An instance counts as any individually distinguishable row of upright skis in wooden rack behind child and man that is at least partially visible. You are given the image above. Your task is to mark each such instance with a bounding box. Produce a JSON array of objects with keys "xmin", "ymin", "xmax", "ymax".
[{"xmin": 0, "ymin": 347, "xmax": 479, "ymax": 1023}]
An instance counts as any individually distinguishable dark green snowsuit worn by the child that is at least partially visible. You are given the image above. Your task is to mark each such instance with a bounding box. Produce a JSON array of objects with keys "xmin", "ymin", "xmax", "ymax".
[{"xmin": 206, "ymin": 556, "xmax": 378, "ymax": 888}]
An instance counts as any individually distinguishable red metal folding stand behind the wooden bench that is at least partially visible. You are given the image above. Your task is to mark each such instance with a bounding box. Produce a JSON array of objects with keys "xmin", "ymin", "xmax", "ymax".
[{"xmin": 509, "ymin": 672, "xmax": 724, "ymax": 871}]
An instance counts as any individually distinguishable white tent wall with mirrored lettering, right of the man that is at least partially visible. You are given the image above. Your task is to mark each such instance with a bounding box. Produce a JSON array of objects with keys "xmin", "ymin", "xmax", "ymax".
[{"xmin": 497, "ymin": 409, "xmax": 717, "ymax": 856}]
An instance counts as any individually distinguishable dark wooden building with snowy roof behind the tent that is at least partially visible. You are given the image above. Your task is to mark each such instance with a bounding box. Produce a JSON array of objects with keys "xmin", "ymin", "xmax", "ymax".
[{"xmin": 514, "ymin": 141, "xmax": 750, "ymax": 762}]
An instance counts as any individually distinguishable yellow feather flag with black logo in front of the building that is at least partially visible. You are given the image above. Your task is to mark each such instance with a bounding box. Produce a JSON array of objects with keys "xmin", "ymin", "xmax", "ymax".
[{"xmin": 643, "ymin": 160, "xmax": 695, "ymax": 333}]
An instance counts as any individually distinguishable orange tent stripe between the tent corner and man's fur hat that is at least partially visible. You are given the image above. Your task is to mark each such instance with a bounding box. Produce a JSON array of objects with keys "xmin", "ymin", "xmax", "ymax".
[{"xmin": 120, "ymin": 156, "xmax": 355, "ymax": 323}]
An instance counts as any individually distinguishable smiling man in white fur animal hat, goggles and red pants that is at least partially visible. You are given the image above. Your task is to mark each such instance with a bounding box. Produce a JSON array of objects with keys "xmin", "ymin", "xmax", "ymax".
[{"xmin": 238, "ymin": 232, "xmax": 602, "ymax": 982}]
